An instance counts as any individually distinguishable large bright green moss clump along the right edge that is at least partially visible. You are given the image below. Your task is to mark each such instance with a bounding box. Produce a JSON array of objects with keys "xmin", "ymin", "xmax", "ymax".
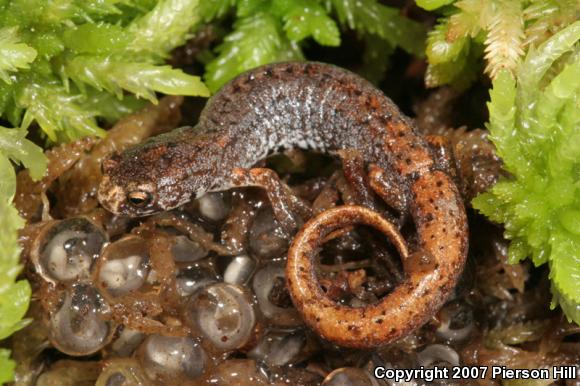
[{"xmin": 473, "ymin": 22, "xmax": 580, "ymax": 324}]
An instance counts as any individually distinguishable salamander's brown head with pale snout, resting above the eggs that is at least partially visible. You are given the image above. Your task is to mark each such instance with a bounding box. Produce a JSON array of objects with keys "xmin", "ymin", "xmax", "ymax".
[{"xmin": 97, "ymin": 132, "xmax": 222, "ymax": 217}]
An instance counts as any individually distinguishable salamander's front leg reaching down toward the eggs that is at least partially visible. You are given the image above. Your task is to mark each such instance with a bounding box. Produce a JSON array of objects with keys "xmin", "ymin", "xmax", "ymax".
[{"xmin": 232, "ymin": 168, "xmax": 312, "ymax": 234}]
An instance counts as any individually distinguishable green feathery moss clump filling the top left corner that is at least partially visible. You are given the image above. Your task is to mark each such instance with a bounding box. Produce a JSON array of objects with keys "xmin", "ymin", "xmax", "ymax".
[{"xmin": 0, "ymin": 0, "xmax": 209, "ymax": 142}]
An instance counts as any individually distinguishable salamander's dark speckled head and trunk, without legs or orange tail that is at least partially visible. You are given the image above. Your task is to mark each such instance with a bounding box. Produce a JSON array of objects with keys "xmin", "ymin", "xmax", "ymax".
[{"xmin": 99, "ymin": 62, "xmax": 433, "ymax": 216}]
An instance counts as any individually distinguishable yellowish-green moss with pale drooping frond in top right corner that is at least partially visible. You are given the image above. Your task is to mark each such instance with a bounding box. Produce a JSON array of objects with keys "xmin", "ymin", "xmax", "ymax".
[{"xmin": 417, "ymin": 0, "xmax": 580, "ymax": 88}]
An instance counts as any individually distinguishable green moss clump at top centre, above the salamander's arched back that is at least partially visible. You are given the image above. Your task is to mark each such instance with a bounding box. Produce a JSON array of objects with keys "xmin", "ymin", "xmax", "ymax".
[{"xmin": 201, "ymin": 0, "xmax": 425, "ymax": 91}]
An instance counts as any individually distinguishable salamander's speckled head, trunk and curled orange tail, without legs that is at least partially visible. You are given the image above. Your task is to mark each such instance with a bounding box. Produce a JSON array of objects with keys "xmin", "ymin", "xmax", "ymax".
[{"xmin": 99, "ymin": 62, "xmax": 467, "ymax": 348}]
